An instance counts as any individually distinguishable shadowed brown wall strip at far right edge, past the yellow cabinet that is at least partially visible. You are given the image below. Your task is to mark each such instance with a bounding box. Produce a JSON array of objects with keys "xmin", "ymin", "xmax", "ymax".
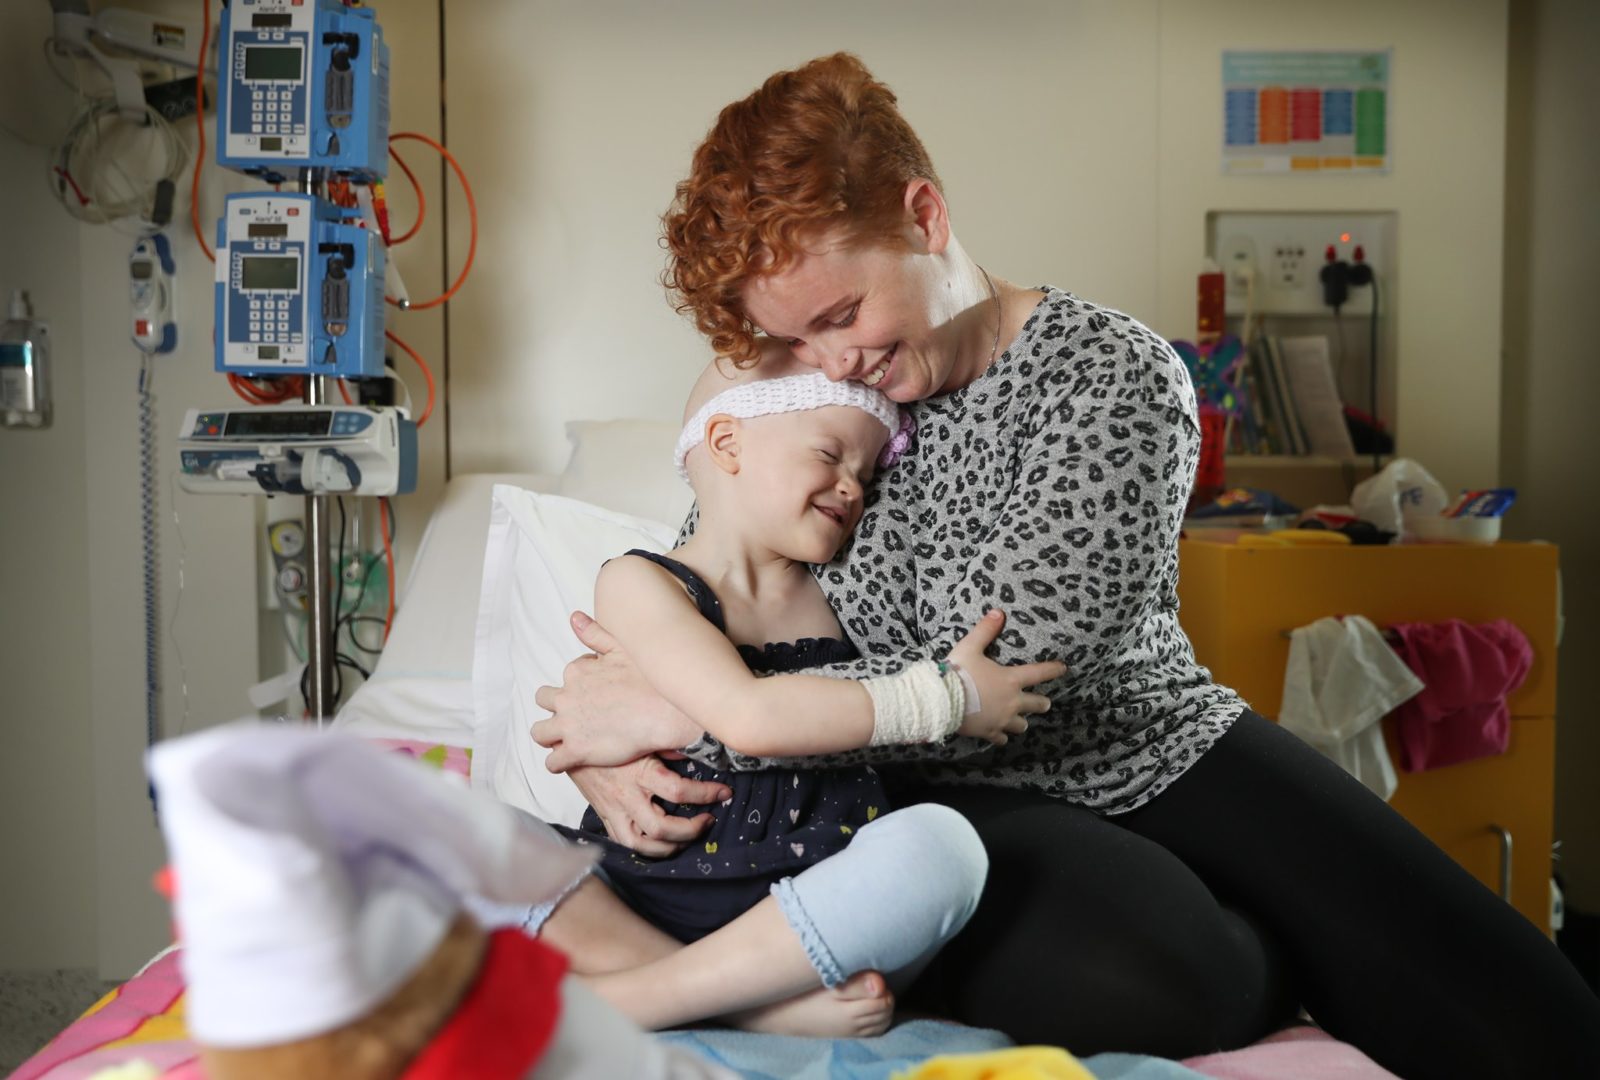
[{"xmin": 1502, "ymin": 0, "xmax": 1600, "ymax": 912}]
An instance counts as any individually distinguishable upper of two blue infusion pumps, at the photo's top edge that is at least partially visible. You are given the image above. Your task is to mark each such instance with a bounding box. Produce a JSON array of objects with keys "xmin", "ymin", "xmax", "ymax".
[{"xmin": 216, "ymin": 0, "xmax": 389, "ymax": 181}]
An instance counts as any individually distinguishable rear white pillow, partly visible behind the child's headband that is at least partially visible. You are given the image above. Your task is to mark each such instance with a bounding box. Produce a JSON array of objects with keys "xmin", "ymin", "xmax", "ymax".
[{"xmin": 555, "ymin": 419, "xmax": 694, "ymax": 525}]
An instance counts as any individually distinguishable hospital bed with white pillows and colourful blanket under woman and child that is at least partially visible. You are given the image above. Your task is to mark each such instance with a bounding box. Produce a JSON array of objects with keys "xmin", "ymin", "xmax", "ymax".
[{"xmin": 14, "ymin": 421, "xmax": 1390, "ymax": 1080}]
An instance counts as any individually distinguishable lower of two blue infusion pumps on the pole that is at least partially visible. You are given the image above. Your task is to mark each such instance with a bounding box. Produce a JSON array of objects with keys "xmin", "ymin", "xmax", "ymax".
[{"xmin": 216, "ymin": 190, "xmax": 384, "ymax": 379}]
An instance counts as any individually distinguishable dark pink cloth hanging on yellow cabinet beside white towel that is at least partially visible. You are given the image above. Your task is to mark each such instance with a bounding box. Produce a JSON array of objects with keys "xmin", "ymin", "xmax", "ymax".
[{"xmin": 1392, "ymin": 619, "xmax": 1533, "ymax": 773}]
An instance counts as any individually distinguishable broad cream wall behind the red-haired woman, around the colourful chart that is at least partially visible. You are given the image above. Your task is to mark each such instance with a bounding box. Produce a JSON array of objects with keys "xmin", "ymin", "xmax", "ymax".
[{"xmin": 446, "ymin": 0, "xmax": 1506, "ymax": 486}]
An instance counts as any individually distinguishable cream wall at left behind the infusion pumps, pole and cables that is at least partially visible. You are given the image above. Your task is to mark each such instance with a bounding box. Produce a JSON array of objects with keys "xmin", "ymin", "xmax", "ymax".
[{"xmin": 0, "ymin": 0, "xmax": 451, "ymax": 978}]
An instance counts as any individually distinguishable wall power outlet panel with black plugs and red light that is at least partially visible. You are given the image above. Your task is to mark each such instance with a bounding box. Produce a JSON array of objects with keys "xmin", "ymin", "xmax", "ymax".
[{"xmin": 1206, "ymin": 210, "xmax": 1395, "ymax": 315}]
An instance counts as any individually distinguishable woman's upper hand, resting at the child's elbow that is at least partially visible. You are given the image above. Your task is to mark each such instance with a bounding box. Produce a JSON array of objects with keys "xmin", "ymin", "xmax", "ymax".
[{"xmin": 531, "ymin": 611, "xmax": 701, "ymax": 773}]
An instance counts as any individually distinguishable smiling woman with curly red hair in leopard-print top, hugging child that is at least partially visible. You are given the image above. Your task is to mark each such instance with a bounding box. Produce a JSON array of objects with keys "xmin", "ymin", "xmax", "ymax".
[{"xmin": 534, "ymin": 54, "xmax": 1600, "ymax": 1077}]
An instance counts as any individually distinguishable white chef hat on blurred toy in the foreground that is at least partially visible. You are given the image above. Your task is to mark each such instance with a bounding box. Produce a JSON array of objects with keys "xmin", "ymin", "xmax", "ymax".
[{"xmin": 149, "ymin": 723, "xmax": 592, "ymax": 1048}]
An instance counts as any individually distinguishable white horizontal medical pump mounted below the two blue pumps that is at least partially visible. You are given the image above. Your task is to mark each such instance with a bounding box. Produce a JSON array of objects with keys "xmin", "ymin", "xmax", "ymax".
[{"xmin": 178, "ymin": 405, "xmax": 416, "ymax": 494}]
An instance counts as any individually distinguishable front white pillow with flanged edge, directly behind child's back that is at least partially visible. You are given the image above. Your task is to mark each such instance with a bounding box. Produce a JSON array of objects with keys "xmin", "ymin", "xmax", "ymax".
[{"xmin": 472, "ymin": 485, "xmax": 677, "ymax": 826}]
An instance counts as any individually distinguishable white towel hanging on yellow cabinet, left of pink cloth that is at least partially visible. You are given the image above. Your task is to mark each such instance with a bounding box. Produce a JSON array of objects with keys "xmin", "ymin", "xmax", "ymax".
[{"xmin": 1278, "ymin": 614, "xmax": 1422, "ymax": 802}]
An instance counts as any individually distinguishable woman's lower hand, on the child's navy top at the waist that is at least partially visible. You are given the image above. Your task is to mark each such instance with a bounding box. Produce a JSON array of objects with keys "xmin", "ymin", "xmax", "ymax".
[{"xmin": 568, "ymin": 757, "xmax": 733, "ymax": 858}]
